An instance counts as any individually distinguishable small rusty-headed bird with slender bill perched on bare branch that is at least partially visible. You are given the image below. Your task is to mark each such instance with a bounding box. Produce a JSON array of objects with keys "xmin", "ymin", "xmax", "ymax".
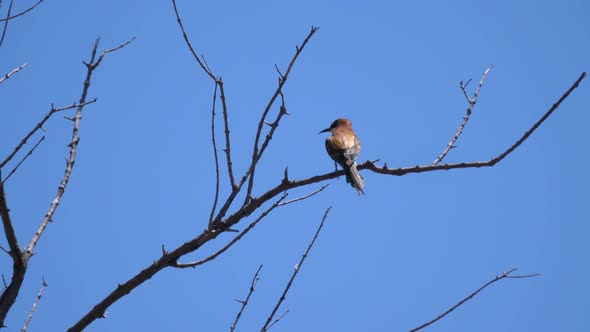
[{"xmin": 320, "ymin": 118, "xmax": 365, "ymax": 195}]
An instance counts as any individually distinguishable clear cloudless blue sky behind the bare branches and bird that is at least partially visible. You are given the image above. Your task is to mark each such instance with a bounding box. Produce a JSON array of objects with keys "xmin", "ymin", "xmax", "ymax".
[{"xmin": 0, "ymin": 0, "xmax": 590, "ymax": 331}]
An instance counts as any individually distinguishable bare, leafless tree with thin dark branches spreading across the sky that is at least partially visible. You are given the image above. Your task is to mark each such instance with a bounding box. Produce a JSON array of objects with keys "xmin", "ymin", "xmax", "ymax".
[{"xmin": 0, "ymin": 0, "xmax": 586, "ymax": 331}]
